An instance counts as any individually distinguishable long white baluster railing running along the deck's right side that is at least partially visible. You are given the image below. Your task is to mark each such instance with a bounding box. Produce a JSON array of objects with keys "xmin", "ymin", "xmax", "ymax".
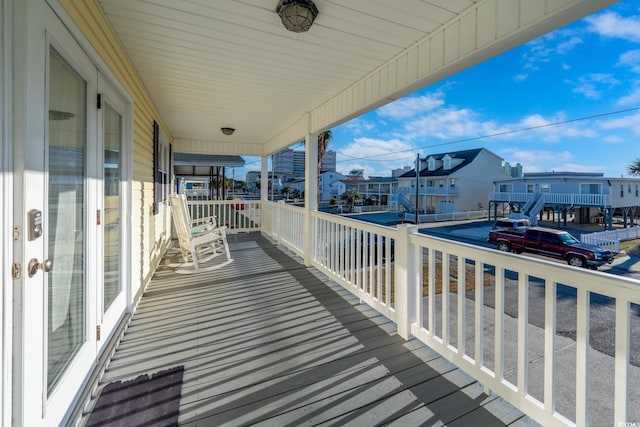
[{"xmin": 262, "ymin": 202, "xmax": 640, "ymax": 426}]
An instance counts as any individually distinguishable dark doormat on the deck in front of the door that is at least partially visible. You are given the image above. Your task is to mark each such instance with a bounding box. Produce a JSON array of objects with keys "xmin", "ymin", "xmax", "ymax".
[{"xmin": 86, "ymin": 366, "xmax": 184, "ymax": 427}]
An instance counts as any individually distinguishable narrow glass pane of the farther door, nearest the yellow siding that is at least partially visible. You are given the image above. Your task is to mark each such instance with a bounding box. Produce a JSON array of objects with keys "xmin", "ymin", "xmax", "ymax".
[{"xmin": 102, "ymin": 104, "xmax": 122, "ymax": 313}]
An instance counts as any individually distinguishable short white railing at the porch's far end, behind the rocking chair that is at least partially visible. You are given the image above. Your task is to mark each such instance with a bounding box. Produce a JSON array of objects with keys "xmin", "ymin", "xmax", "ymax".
[{"xmin": 187, "ymin": 200, "xmax": 261, "ymax": 232}]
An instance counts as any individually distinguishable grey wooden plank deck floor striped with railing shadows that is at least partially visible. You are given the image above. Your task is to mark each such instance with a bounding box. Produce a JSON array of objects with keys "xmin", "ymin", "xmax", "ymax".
[{"xmin": 82, "ymin": 233, "xmax": 535, "ymax": 426}]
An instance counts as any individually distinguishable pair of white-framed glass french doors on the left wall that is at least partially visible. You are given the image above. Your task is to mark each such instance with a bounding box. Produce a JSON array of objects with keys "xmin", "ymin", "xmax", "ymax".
[{"xmin": 14, "ymin": 0, "xmax": 127, "ymax": 426}]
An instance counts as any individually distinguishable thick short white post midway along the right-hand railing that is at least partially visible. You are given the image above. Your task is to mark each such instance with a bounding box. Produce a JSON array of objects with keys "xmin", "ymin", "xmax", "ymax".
[{"xmin": 394, "ymin": 224, "xmax": 419, "ymax": 340}]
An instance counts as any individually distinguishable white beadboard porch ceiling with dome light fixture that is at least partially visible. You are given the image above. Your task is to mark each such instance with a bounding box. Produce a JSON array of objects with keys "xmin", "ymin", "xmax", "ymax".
[{"xmin": 99, "ymin": 0, "xmax": 613, "ymax": 154}]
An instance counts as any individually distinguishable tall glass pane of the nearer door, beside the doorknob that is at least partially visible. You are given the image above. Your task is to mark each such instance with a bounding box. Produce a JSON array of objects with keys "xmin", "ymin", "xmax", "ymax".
[{"xmin": 47, "ymin": 48, "xmax": 87, "ymax": 393}]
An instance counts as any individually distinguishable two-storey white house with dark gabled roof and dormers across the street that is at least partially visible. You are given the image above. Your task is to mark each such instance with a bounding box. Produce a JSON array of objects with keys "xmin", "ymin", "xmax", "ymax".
[{"xmin": 393, "ymin": 148, "xmax": 506, "ymax": 214}]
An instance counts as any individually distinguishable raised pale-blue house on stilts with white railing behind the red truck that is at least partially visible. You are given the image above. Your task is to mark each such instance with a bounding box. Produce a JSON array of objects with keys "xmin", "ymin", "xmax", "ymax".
[{"xmin": 489, "ymin": 172, "xmax": 640, "ymax": 229}]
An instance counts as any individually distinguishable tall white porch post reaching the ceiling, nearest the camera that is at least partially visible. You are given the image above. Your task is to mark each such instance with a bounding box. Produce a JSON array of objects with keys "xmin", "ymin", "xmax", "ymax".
[{"xmin": 304, "ymin": 133, "xmax": 318, "ymax": 266}]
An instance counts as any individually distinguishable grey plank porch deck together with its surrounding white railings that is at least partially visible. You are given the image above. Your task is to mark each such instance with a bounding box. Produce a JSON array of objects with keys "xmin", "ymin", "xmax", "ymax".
[{"xmin": 80, "ymin": 200, "xmax": 640, "ymax": 425}]
